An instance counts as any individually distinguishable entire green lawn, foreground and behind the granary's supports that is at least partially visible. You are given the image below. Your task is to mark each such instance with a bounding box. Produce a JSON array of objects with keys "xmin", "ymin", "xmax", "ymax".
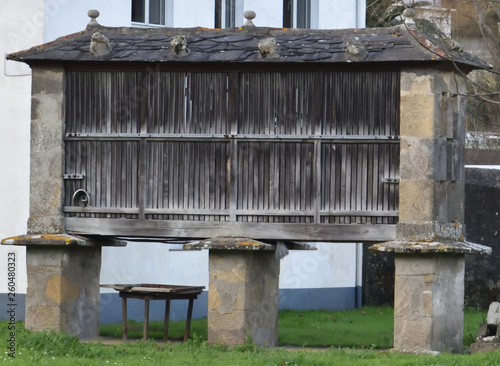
[{"xmin": 0, "ymin": 308, "xmax": 500, "ymax": 366}]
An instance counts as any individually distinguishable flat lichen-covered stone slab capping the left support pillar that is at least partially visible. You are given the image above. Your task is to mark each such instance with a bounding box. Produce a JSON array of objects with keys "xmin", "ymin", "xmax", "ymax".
[{"xmin": 0, "ymin": 234, "xmax": 127, "ymax": 247}]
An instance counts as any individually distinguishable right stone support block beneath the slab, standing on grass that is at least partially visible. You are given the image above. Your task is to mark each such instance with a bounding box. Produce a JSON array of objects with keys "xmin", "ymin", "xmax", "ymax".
[{"xmin": 394, "ymin": 253, "xmax": 465, "ymax": 353}]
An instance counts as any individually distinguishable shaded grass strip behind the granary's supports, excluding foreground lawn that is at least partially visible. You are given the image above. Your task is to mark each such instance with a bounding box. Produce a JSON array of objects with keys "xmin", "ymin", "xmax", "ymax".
[{"xmin": 100, "ymin": 307, "xmax": 485, "ymax": 349}]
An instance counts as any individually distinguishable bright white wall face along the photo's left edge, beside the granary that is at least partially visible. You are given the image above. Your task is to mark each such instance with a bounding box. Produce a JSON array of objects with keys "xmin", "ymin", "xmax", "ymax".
[{"xmin": 0, "ymin": 0, "xmax": 44, "ymax": 293}]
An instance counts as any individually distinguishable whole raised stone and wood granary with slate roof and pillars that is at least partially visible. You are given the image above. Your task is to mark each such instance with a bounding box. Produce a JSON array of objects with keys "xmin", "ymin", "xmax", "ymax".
[{"xmin": 3, "ymin": 7, "xmax": 488, "ymax": 352}]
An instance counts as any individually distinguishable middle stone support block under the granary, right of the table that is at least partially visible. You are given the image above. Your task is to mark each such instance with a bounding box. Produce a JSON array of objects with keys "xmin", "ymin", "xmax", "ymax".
[{"xmin": 208, "ymin": 250, "xmax": 280, "ymax": 346}]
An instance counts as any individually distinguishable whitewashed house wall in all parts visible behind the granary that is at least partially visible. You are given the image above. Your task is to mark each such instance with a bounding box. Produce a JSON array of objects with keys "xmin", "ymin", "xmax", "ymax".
[{"xmin": 0, "ymin": 0, "xmax": 365, "ymax": 314}]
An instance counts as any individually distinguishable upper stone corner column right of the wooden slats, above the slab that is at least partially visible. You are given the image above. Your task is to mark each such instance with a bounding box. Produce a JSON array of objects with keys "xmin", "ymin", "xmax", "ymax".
[{"xmin": 397, "ymin": 70, "xmax": 465, "ymax": 242}]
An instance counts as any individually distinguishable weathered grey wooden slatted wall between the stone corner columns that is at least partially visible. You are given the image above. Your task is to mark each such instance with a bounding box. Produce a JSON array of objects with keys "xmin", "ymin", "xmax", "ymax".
[{"xmin": 64, "ymin": 71, "xmax": 399, "ymax": 239}]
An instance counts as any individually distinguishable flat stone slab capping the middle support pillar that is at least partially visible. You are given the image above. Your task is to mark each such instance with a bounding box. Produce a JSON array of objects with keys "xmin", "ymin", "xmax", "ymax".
[{"xmin": 183, "ymin": 237, "xmax": 316, "ymax": 251}]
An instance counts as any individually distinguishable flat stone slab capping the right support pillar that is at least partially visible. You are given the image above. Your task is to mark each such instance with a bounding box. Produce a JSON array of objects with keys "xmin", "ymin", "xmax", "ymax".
[{"xmin": 369, "ymin": 241, "xmax": 491, "ymax": 254}]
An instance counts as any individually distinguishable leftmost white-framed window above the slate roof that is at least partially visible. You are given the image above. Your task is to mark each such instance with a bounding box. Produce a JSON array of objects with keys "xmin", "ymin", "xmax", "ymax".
[{"xmin": 132, "ymin": 0, "xmax": 171, "ymax": 26}]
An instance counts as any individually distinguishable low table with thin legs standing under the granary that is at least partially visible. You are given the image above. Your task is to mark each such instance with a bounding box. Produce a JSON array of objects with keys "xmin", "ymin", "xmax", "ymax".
[{"xmin": 101, "ymin": 283, "xmax": 205, "ymax": 342}]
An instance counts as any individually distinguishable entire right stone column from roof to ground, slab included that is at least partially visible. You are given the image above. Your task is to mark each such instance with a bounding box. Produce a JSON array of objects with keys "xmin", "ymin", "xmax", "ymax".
[{"xmin": 370, "ymin": 70, "xmax": 491, "ymax": 353}]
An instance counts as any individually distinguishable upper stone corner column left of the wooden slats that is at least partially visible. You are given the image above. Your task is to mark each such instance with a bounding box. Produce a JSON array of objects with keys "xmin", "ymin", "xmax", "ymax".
[{"xmin": 28, "ymin": 67, "xmax": 65, "ymax": 234}]
